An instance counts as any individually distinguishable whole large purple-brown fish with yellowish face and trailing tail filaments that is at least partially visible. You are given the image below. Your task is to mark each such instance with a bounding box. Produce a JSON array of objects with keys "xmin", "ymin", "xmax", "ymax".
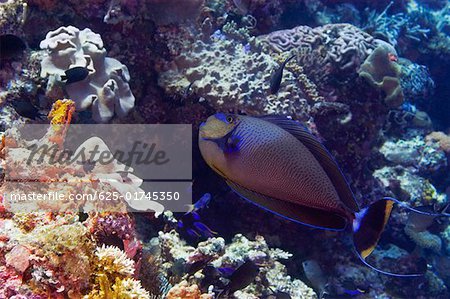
[{"xmin": 199, "ymin": 113, "xmax": 426, "ymax": 277}]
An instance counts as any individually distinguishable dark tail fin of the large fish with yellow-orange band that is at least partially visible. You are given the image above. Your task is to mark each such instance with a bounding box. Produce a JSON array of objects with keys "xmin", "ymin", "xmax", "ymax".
[{"xmin": 353, "ymin": 197, "xmax": 426, "ymax": 277}]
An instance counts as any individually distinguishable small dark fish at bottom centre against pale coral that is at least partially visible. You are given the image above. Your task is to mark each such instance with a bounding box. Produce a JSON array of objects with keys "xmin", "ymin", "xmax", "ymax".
[{"xmin": 217, "ymin": 260, "xmax": 259, "ymax": 298}]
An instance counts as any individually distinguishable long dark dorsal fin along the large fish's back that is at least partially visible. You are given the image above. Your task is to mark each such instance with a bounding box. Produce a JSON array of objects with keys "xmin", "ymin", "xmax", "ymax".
[{"xmin": 260, "ymin": 115, "xmax": 359, "ymax": 212}]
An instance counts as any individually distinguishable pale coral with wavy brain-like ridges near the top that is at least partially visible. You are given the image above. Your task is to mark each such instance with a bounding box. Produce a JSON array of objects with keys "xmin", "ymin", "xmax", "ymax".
[{"xmin": 259, "ymin": 24, "xmax": 395, "ymax": 88}]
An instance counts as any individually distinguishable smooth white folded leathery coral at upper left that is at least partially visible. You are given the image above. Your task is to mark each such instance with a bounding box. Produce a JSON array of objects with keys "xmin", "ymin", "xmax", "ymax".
[{"xmin": 40, "ymin": 26, "xmax": 135, "ymax": 123}]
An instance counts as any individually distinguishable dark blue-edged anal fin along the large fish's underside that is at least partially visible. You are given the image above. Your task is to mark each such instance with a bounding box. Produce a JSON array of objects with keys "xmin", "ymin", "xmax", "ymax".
[{"xmin": 227, "ymin": 180, "xmax": 347, "ymax": 230}]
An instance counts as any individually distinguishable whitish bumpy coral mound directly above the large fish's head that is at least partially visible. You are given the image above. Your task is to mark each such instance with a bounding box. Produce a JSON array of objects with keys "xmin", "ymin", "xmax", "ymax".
[{"xmin": 159, "ymin": 31, "xmax": 305, "ymax": 116}]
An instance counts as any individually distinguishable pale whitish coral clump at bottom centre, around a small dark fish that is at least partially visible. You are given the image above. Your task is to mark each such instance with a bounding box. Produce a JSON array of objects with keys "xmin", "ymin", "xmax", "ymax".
[{"xmin": 149, "ymin": 231, "xmax": 316, "ymax": 298}]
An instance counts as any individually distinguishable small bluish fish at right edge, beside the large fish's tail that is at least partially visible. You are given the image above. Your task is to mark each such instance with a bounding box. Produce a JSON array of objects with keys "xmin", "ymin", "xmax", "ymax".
[{"xmin": 406, "ymin": 204, "xmax": 450, "ymax": 232}]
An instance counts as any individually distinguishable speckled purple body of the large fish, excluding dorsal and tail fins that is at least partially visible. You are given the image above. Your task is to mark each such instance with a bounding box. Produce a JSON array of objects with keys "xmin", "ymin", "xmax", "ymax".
[{"xmin": 200, "ymin": 116, "xmax": 358, "ymax": 230}]
